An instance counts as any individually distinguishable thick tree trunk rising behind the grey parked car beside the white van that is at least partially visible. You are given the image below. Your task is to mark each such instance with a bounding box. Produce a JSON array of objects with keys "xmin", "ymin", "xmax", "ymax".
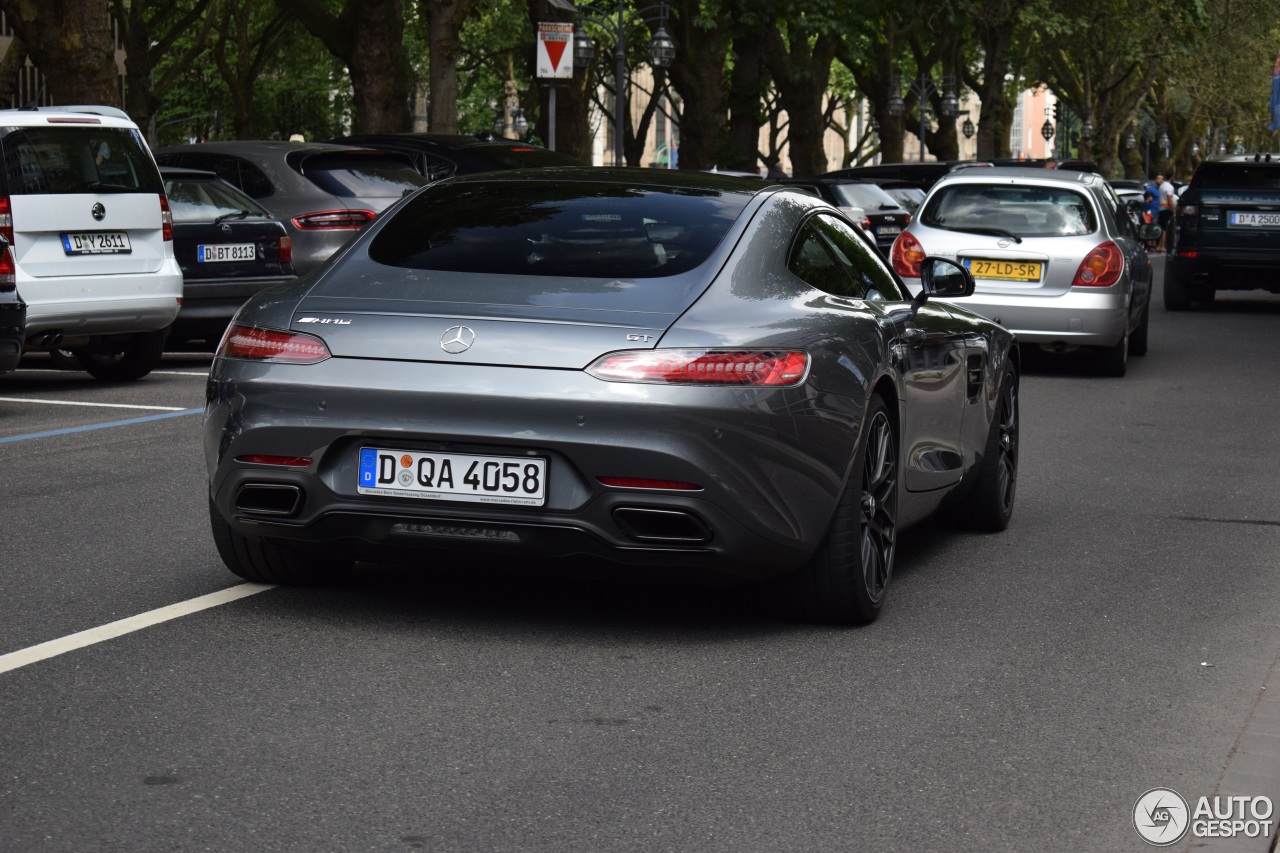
[{"xmin": 275, "ymin": 0, "xmax": 412, "ymax": 133}]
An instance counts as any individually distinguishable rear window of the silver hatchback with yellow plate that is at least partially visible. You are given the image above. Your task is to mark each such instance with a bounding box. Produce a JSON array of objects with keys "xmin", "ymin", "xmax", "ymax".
[{"xmin": 919, "ymin": 183, "xmax": 1098, "ymax": 237}]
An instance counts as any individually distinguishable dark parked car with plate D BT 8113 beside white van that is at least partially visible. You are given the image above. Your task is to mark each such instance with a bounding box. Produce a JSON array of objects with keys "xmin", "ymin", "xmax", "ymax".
[{"xmin": 160, "ymin": 167, "xmax": 294, "ymax": 346}]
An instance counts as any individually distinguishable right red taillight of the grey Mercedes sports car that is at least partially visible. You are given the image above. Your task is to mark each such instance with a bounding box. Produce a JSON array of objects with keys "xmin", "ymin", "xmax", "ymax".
[{"xmin": 586, "ymin": 350, "xmax": 809, "ymax": 386}]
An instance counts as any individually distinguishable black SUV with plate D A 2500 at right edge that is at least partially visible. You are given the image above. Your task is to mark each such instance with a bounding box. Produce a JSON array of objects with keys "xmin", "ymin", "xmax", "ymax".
[{"xmin": 1165, "ymin": 154, "xmax": 1280, "ymax": 311}]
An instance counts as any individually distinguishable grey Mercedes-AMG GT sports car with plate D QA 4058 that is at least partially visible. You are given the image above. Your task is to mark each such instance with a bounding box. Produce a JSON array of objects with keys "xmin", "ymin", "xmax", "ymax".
[{"xmin": 205, "ymin": 169, "xmax": 1019, "ymax": 624}]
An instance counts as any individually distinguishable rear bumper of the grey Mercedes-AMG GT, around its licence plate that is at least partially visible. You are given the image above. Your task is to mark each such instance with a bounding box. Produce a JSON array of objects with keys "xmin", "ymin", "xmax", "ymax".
[{"xmin": 205, "ymin": 350, "xmax": 861, "ymax": 578}]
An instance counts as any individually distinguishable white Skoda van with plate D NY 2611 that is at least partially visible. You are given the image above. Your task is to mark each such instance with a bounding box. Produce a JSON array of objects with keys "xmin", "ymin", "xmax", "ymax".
[{"xmin": 0, "ymin": 106, "xmax": 182, "ymax": 379}]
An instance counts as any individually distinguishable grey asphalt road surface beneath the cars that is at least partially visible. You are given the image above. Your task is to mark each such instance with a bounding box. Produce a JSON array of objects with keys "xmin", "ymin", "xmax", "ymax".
[{"xmin": 0, "ymin": 261, "xmax": 1280, "ymax": 853}]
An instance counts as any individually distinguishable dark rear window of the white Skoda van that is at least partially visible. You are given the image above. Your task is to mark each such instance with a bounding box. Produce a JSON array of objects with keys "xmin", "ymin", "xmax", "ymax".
[{"xmin": 0, "ymin": 124, "xmax": 161, "ymax": 196}]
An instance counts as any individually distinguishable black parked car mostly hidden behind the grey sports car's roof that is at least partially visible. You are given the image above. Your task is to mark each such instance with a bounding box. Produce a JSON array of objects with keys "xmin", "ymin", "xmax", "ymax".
[{"xmin": 332, "ymin": 133, "xmax": 590, "ymax": 181}]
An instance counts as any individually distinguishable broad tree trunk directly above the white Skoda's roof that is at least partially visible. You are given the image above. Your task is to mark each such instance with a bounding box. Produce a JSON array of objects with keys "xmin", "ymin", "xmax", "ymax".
[{"xmin": 0, "ymin": 0, "xmax": 120, "ymax": 105}]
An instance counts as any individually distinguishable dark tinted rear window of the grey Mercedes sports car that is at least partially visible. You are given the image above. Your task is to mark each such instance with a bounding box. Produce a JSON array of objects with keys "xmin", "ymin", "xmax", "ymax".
[{"xmin": 369, "ymin": 181, "xmax": 750, "ymax": 278}]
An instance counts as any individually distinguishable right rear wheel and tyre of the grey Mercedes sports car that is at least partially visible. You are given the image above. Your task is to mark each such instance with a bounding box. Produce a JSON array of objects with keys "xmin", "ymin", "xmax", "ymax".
[{"xmin": 791, "ymin": 396, "xmax": 899, "ymax": 625}]
